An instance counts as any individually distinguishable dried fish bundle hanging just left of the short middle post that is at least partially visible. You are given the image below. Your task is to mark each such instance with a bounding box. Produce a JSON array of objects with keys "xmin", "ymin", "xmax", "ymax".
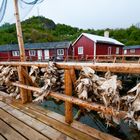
[{"xmin": 34, "ymin": 62, "xmax": 64, "ymax": 102}]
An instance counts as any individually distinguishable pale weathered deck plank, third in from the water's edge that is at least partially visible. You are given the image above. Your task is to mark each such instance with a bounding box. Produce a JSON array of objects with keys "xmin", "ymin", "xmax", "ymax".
[{"xmin": 2, "ymin": 101, "xmax": 72, "ymax": 140}]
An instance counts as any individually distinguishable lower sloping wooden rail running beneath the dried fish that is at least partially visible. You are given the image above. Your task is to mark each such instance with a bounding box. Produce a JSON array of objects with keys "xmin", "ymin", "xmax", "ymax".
[{"xmin": 11, "ymin": 82, "xmax": 126, "ymax": 119}]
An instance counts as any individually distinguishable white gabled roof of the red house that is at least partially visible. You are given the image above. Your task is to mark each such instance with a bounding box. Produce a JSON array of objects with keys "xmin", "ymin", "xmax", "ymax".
[{"xmin": 72, "ymin": 33, "xmax": 124, "ymax": 46}]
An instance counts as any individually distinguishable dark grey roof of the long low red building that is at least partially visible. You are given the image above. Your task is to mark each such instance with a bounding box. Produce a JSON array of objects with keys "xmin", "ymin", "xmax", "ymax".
[{"xmin": 0, "ymin": 41, "xmax": 71, "ymax": 52}]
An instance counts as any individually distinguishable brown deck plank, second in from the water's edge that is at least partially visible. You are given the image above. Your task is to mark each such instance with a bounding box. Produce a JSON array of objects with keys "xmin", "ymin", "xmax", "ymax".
[{"xmin": 8, "ymin": 102, "xmax": 96, "ymax": 140}]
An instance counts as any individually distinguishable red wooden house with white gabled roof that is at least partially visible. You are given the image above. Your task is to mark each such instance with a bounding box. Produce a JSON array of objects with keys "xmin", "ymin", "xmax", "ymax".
[{"xmin": 72, "ymin": 33, "xmax": 124, "ymax": 58}]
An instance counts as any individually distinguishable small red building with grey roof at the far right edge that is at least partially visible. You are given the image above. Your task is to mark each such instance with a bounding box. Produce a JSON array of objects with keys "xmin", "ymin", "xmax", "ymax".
[{"xmin": 123, "ymin": 45, "xmax": 140, "ymax": 55}]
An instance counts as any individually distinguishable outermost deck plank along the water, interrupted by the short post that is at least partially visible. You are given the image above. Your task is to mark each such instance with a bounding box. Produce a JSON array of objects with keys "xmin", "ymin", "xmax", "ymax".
[{"xmin": 26, "ymin": 103, "xmax": 118, "ymax": 140}]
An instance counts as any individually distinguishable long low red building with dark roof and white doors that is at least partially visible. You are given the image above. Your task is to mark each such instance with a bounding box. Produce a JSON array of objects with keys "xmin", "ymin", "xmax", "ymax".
[{"xmin": 0, "ymin": 41, "xmax": 71, "ymax": 61}]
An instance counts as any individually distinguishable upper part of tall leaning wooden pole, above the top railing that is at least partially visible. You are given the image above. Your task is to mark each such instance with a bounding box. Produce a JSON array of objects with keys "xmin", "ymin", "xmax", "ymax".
[{"xmin": 14, "ymin": 0, "xmax": 26, "ymax": 62}]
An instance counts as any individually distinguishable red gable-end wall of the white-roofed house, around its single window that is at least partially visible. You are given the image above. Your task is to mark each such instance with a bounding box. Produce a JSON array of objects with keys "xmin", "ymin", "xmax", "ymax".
[{"xmin": 73, "ymin": 36, "xmax": 94, "ymax": 57}]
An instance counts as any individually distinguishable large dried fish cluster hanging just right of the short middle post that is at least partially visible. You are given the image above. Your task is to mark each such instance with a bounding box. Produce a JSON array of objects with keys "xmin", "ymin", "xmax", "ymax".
[{"xmin": 75, "ymin": 67, "xmax": 122, "ymax": 125}]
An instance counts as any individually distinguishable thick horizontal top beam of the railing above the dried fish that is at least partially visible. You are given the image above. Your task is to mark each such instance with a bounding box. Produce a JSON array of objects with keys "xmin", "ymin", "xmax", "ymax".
[{"xmin": 0, "ymin": 62, "xmax": 140, "ymax": 74}]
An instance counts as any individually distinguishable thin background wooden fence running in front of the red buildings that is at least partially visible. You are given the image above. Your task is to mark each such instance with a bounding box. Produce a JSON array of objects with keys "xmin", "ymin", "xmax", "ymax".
[{"xmin": 0, "ymin": 55, "xmax": 140, "ymax": 63}]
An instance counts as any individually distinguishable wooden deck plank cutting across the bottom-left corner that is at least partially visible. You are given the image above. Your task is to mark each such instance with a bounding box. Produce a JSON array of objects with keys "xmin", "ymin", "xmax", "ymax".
[{"xmin": 0, "ymin": 119, "xmax": 27, "ymax": 140}]
